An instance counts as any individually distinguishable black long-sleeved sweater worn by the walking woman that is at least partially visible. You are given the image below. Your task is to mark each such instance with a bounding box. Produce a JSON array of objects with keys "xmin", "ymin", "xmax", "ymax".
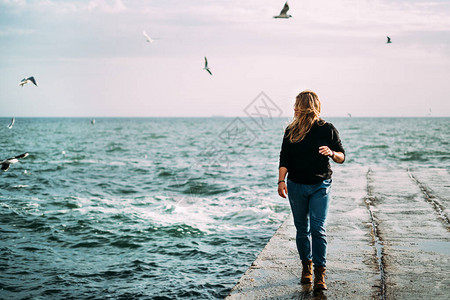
[{"xmin": 280, "ymin": 122, "xmax": 345, "ymax": 184}]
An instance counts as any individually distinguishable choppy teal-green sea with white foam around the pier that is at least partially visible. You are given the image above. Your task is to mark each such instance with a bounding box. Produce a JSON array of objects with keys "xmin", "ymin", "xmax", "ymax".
[{"xmin": 0, "ymin": 117, "xmax": 450, "ymax": 299}]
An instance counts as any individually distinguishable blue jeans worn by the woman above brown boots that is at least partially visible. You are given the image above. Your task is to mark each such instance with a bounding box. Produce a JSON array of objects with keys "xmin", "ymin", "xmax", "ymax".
[{"xmin": 287, "ymin": 179, "xmax": 332, "ymax": 267}]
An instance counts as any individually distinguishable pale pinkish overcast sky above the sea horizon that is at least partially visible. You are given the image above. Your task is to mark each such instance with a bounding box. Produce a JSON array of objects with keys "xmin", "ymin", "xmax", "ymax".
[{"xmin": 0, "ymin": 0, "xmax": 450, "ymax": 117}]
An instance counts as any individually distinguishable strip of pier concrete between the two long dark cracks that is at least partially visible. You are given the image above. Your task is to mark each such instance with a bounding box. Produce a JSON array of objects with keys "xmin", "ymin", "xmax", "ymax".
[{"xmin": 369, "ymin": 169, "xmax": 450, "ymax": 299}]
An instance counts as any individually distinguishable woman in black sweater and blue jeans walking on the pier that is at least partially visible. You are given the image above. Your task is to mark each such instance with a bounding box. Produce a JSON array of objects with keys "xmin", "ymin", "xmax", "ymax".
[{"xmin": 278, "ymin": 90, "xmax": 345, "ymax": 291}]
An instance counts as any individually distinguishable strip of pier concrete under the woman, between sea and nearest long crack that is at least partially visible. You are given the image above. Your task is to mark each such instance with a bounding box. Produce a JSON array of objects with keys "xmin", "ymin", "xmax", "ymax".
[{"xmin": 227, "ymin": 168, "xmax": 379, "ymax": 300}]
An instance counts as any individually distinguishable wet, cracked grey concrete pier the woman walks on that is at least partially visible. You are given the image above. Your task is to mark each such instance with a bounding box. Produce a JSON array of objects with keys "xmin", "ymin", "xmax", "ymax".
[{"xmin": 226, "ymin": 166, "xmax": 450, "ymax": 300}]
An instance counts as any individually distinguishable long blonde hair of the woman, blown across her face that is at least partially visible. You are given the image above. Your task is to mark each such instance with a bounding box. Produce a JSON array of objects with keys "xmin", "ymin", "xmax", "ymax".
[{"xmin": 287, "ymin": 90, "xmax": 325, "ymax": 143}]
